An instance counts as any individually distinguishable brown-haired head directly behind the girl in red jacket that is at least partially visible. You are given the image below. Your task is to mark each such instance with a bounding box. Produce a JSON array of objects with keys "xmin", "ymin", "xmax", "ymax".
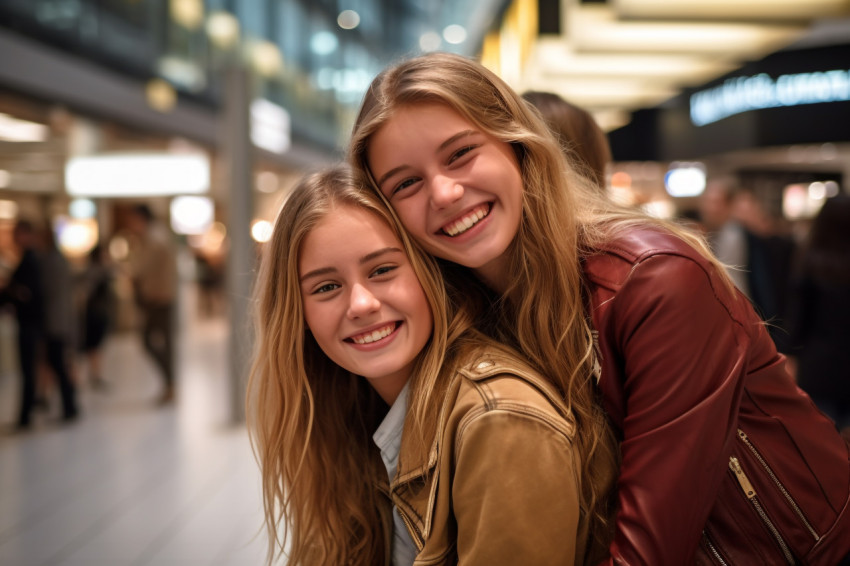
[{"xmin": 522, "ymin": 91, "xmax": 611, "ymax": 190}]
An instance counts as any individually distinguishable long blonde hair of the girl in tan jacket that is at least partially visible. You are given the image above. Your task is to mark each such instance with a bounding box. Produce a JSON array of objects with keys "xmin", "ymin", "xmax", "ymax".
[{"xmin": 247, "ymin": 165, "xmax": 490, "ymax": 565}]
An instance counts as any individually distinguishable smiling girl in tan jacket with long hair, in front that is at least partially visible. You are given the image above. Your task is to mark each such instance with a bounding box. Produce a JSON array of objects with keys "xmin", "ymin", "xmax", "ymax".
[{"xmin": 248, "ymin": 167, "xmax": 616, "ymax": 566}]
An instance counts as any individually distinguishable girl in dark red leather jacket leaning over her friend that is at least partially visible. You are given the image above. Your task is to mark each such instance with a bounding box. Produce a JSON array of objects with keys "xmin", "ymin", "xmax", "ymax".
[{"xmin": 349, "ymin": 53, "xmax": 850, "ymax": 566}]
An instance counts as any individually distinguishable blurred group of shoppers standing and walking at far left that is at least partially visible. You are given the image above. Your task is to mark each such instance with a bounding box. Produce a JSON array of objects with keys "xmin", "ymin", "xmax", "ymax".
[{"xmin": 0, "ymin": 204, "xmax": 177, "ymax": 432}]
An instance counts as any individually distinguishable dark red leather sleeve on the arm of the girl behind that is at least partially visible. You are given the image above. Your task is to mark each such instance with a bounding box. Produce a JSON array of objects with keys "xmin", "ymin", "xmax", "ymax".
[{"xmin": 600, "ymin": 255, "xmax": 750, "ymax": 566}]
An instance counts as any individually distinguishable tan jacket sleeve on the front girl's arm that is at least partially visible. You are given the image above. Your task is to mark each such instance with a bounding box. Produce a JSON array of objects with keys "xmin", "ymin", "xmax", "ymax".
[{"xmin": 452, "ymin": 409, "xmax": 579, "ymax": 566}]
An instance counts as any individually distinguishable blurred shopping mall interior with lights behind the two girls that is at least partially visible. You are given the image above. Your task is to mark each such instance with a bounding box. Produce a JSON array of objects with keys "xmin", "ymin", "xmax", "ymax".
[{"xmin": 0, "ymin": 0, "xmax": 850, "ymax": 566}]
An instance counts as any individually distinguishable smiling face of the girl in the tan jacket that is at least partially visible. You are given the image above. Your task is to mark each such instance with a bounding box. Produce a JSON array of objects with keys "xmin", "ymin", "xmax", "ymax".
[{"xmin": 298, "ymin": 206, "xmax": 433, "ymax": 404}]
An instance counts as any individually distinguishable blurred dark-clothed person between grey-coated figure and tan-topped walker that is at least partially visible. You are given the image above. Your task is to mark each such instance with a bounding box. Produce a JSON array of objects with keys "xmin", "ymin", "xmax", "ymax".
[{"xmin": 78, "ymin": 243, "xmax": 114, "ymax": 391}]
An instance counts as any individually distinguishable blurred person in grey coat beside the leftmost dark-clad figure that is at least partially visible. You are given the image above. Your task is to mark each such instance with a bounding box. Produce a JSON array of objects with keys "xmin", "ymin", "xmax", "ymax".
[{"xmin": 41, "ymin": 224, "xmax": 79, "ymax": 422}]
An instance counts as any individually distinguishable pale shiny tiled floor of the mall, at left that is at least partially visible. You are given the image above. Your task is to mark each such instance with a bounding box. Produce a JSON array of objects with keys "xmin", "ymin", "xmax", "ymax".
[{"xmin": 0, "ymin": 302, "xmax": 265, "ymax": 566}]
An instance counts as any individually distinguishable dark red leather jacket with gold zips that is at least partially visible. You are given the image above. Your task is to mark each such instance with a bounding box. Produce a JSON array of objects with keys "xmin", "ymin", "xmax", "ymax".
[{"xmin": 585, "ymin": 229, "xmax": 850, "ymax": 566}]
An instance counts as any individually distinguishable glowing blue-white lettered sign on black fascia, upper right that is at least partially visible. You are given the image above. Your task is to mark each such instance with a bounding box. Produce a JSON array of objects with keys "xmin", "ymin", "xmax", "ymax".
[{"xmin": 690, "ymin": 70, "xmax": 850, "ymax": 126}]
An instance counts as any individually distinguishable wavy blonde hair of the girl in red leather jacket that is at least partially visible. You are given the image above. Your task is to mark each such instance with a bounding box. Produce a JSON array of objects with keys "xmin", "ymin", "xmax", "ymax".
[{"xmin": 347, "ymin": 53, "xmax": 723, "ymax": 548}]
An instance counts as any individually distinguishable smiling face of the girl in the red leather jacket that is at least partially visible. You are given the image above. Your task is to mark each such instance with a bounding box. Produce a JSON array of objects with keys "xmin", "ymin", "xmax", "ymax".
[{"xmin": 367, "ymin": 103, "xmax": 522, "ymax": 290}]
